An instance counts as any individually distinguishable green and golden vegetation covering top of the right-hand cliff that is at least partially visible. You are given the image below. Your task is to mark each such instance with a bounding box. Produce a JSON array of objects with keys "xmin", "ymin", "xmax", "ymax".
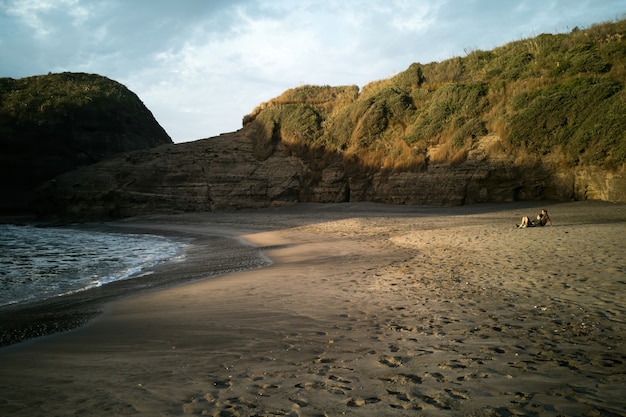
[{"xmin": 244, "ymin": 20, "xmax": 626, "ymax": 171}]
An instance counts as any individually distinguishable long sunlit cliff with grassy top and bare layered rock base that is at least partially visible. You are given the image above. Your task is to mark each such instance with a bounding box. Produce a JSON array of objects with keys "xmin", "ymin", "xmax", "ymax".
[{"xmin": 31, "ymin": 21, "xmax": 626, "ymax": 219}]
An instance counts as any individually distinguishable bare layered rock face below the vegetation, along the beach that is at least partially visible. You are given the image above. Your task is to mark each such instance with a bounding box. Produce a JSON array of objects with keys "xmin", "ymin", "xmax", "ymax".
[{"xmin": 31, "ymin": 125, "xmax": 626, "ymax": 220}]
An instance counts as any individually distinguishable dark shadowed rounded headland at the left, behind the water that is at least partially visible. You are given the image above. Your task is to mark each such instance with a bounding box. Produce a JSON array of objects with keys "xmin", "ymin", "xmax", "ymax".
[{"xmin": 0, "ymin": 73, "xmax": 172, "ymax": 212}]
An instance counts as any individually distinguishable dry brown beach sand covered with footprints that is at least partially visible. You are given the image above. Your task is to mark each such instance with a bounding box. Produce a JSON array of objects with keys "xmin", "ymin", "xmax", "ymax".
[{"xmin": 0, "ymin": 202, "xmax": 626, "ymax": 416}]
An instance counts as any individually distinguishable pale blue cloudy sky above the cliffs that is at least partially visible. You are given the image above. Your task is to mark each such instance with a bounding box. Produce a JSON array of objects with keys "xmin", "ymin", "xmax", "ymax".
[{"xmin": 0, "ymin": 0, "xmax": 626, "ymax": 143}]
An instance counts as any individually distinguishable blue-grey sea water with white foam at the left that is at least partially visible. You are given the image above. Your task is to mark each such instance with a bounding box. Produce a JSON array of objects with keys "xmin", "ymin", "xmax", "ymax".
[{"xmin": 0, "ymin": 225, "xmax": 183, "ymax": 306}]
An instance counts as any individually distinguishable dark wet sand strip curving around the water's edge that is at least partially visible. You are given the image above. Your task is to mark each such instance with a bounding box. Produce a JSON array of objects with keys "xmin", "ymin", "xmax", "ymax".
[{"xmin": 0, "ymin": 222, "xmax": 270, "ymax": 348}]
